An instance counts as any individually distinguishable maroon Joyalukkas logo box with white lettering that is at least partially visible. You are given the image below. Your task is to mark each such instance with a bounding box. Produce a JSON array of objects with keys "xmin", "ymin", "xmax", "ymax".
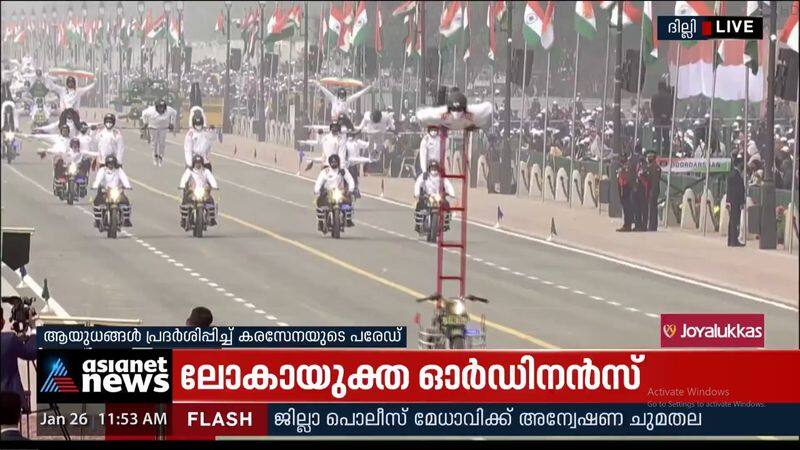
[{"xmin": 660, "ymin": 314, "xmax": 764, "ymax": 347}]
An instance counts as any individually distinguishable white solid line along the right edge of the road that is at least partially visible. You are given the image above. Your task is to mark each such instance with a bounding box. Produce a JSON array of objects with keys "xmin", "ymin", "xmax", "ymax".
[{"xmin": 195, "ymin": 149, "xmax": 800, "ymax": 312}]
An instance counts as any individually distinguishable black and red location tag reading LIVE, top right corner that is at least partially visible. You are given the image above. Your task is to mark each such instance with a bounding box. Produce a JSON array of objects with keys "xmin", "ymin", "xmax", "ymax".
[{"xmin": 658, "ymin": 16, "xmax": 764, "ymax": 41}]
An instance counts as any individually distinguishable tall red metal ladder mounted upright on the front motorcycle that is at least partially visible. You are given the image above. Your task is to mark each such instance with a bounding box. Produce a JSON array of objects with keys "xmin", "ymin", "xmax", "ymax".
[{"xmin": 436, "ymin": 128, "xmax": 472, "ymax": 298}]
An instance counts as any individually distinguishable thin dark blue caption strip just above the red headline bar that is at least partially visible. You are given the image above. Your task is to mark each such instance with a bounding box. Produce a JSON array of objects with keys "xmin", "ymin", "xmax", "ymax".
[{"xmin": 36, "ymin": 325, "xmax": 407, "ymax": 350}]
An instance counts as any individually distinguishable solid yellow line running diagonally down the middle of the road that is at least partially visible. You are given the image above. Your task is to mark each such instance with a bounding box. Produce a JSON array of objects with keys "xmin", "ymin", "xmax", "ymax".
[{"xmin": 130, "ymin": 178, "xmax": 559, "ymax": 349}]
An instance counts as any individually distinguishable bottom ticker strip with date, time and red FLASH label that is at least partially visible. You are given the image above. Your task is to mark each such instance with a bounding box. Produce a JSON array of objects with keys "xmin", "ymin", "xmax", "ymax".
[{"xmin": 36, "ymin": 402, "xmax": 800, "ymax": 440}]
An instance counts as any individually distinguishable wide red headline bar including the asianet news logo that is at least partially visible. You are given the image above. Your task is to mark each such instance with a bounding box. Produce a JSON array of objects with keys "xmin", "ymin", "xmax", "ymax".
[{"xmin": 37, "ymin": 349, "xmax": 800, "ymax": 404}]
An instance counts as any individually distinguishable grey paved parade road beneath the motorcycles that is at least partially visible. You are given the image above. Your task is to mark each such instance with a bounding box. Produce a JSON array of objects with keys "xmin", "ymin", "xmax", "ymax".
[{"xmin": 2, "ymin": 125, "xmax": 798, "ymax": 348}]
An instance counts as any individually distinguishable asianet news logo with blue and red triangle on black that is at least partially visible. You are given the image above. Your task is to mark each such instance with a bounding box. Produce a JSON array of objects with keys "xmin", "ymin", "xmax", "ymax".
[{"xmin": 37, "ymin": 350, "xmax": 172, "ymax": 403}]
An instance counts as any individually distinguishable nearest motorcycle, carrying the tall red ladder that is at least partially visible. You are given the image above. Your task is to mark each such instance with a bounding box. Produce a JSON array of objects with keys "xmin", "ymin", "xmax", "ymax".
[{"xmin": 417, "ymin": 294, "xmax": 489, "ymax": 350}]
